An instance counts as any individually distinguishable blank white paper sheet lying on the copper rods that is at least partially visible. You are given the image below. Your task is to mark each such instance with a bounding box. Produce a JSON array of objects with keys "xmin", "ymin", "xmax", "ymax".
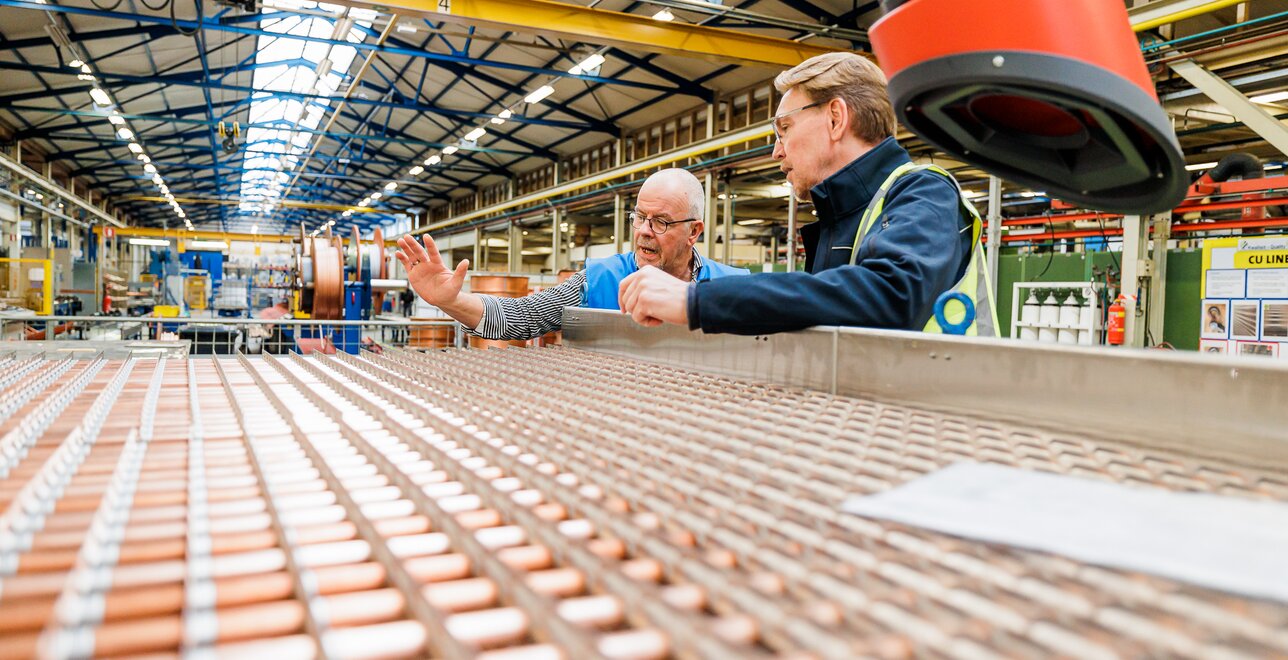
[{"xmin": 842, "ymin": 463, "xmax": 1288, "ymax": 602}]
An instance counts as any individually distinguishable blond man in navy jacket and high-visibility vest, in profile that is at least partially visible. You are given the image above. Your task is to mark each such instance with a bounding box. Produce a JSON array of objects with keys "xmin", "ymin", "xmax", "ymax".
[{"xmin": 620, "ymin": 53, "xmax": 997, "ymax": 335}]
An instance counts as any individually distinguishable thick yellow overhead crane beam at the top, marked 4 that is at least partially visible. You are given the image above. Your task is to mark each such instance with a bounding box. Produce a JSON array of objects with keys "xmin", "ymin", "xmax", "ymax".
[{"xmin": 329, "ymin": 0, "xmax": 837, "ymax": 68}]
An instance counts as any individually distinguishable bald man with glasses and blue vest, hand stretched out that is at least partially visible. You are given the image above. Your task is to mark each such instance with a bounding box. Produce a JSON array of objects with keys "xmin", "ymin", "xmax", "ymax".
[{"xmin": 398, "ymin": 168, "xmax": 747, "ymax": 339}]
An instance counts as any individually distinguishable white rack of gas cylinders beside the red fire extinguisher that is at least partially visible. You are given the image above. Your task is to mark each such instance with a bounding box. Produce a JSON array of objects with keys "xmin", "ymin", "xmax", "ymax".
[{"xmin": 1010, "ymin": 282, "xmax": 1104, "ymax": 345}]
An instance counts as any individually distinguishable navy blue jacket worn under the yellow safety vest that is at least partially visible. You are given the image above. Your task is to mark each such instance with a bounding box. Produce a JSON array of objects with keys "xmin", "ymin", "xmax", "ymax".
[{"xmin": 689, "ymin": 138, "xmax": 971, "ymax": 335}]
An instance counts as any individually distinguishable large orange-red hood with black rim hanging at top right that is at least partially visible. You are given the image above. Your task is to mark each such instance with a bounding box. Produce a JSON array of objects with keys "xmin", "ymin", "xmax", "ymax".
[{"xmin": 869, "ymin": 0, "xmax": 1189, "ymax": 213}]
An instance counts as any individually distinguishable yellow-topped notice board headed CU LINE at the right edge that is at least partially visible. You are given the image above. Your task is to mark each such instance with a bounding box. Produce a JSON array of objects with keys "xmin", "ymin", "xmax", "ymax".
[{"xmin": 1199, "ymin": 236, "xmax": 1288, "ymax": 360}]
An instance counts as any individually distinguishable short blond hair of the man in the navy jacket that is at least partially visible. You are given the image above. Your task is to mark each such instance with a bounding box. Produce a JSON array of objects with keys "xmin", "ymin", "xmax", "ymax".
[{"xmin": 774, "ymin": 53, "xmax": 896, "ymax": 144}]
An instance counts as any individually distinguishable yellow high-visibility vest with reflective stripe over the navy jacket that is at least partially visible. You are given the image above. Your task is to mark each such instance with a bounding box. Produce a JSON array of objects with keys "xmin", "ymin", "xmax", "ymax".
[{"xmin": 850, "ymin": 162, "xmax": 997, "ymax": 336}]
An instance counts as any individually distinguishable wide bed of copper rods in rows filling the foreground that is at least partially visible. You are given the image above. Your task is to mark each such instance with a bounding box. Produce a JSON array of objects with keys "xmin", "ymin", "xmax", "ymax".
[{"xmin": 0, "ymin": 347, "xmax": 1288, "ymax": 660}]
